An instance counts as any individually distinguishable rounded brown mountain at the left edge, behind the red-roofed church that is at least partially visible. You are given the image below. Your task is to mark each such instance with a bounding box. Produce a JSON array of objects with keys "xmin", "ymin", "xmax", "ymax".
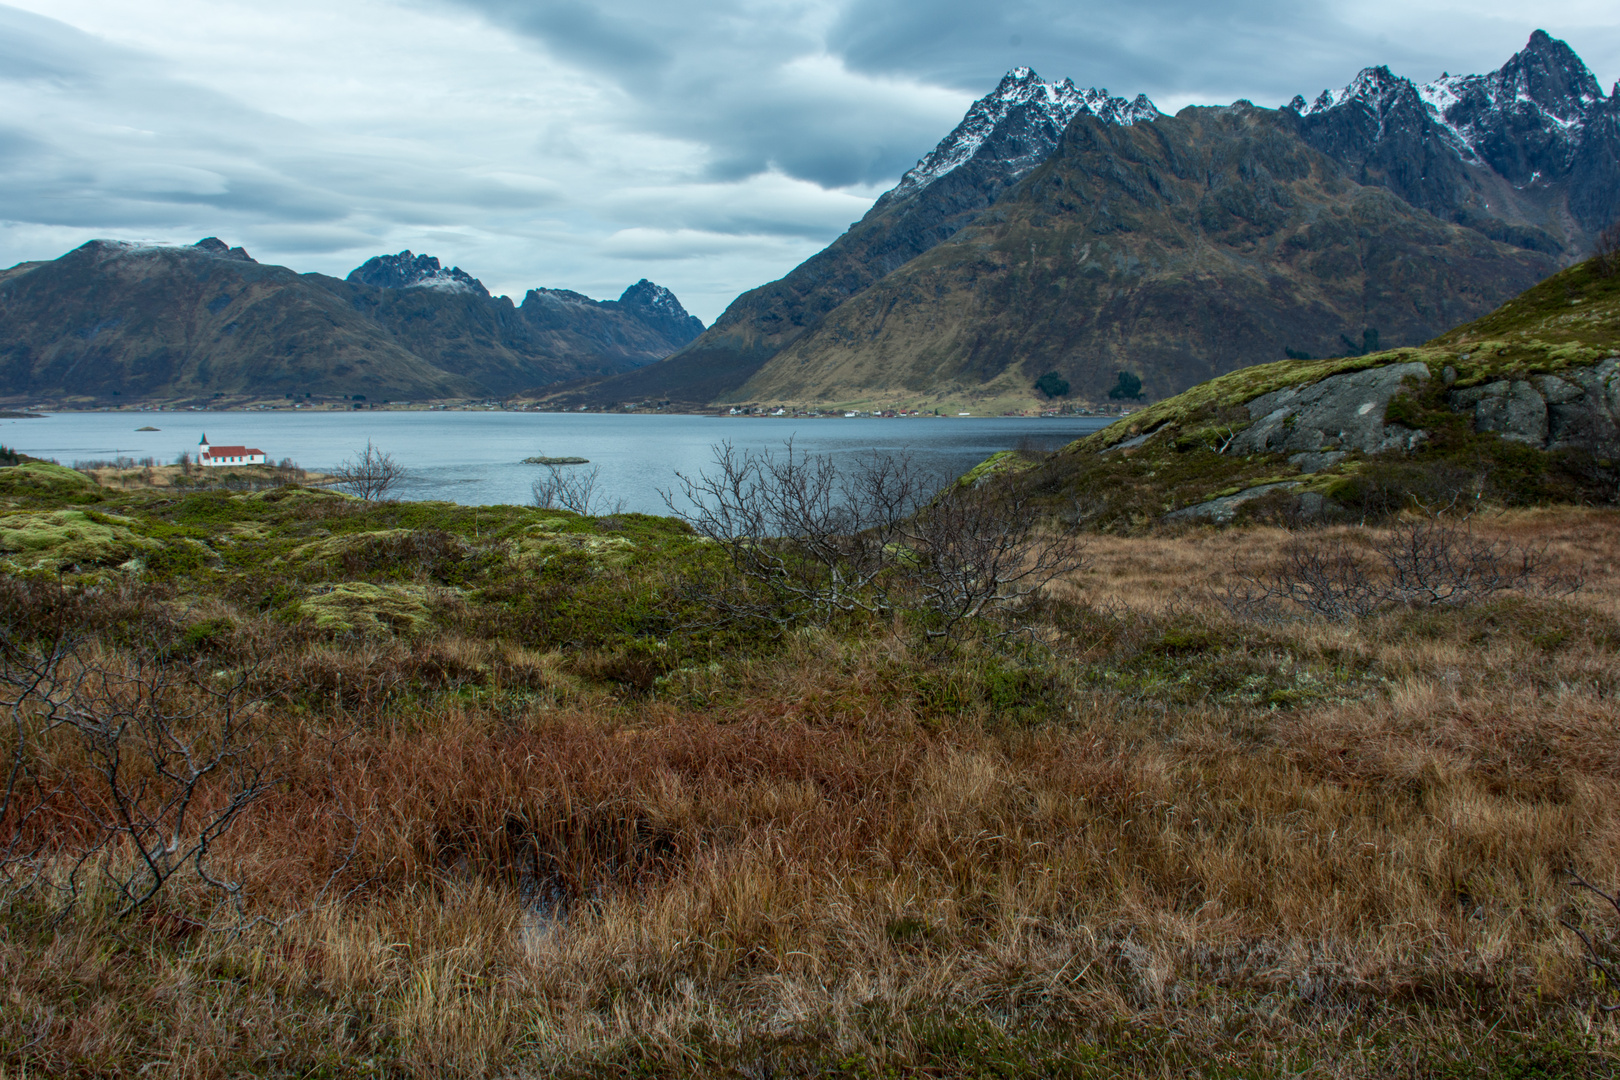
[{"xmin": 0, "ymin": 240, "xmax": 473, "ymax": 398}]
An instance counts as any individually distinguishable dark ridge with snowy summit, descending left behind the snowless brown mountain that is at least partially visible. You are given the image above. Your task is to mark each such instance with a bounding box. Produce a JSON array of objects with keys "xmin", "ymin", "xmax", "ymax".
[{"xmin": 550, "ymin": 68, "xmax": 1160, "ymax": 403}]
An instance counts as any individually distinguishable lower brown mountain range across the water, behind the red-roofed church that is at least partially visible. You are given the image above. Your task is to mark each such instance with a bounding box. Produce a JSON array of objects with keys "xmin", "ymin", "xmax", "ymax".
[{"xmin": 0, "ymin": 236, "xmax": 703, "ymax": 400}]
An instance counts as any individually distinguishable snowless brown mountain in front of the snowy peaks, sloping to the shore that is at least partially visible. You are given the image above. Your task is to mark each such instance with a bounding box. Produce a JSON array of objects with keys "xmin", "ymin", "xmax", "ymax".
[{"xmin": 735, "ymin": 104, "xmax": 1555, "ymax": 402}]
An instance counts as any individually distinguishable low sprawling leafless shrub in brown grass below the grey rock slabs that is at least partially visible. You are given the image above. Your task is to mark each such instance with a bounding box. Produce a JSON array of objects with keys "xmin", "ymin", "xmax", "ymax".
[{"xmin": 1225, "ymin": 515, "xmax": 1581, "ymax": 622}]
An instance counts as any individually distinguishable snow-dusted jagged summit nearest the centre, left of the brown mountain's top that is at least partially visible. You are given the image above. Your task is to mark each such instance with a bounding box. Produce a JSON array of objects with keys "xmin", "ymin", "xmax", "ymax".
[{"xmin": 889, "ymin": 68, "xmax": 1162, "ymax": 198}]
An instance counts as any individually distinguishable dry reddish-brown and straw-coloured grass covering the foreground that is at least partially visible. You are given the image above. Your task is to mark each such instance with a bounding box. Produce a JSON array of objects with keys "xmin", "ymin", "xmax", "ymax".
[{"xmin": 0, "ymin": 510, "xmax": 1620, "ymax": 1077}]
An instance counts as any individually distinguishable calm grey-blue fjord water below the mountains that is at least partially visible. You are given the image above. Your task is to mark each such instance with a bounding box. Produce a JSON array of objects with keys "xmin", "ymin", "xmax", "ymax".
[{"xmin": 0, "ymin": 411, "xmax": 1108, "ymax": 513}]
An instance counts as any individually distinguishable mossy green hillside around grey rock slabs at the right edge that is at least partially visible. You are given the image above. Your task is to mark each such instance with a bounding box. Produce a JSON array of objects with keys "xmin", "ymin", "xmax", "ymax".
[{"xmin": 984, "ymin": 262, "xmax": 1620, "ymax": 529}]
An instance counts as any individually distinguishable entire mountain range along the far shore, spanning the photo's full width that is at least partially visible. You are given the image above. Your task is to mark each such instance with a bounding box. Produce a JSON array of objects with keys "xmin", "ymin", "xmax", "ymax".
[{"xmin": 0, "ymin": 31, "xmax": 1620, "ymax": 410}]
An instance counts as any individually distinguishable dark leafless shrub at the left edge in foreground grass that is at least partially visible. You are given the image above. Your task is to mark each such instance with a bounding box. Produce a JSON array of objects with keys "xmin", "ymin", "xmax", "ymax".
[{"xmin": 0, "ymin": 631, "xmax": 269, "ymax": 916}]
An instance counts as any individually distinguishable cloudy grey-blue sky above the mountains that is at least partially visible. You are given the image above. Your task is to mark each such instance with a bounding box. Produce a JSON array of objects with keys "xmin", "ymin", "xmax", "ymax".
[{"xmin": 0, "ymin": 0, "xmax": 1620, "ymax": 322}]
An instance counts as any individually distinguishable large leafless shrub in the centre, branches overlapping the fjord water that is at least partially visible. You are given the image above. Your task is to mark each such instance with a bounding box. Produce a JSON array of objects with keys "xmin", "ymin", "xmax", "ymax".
[{"xmin": 664, "ymin": 440, "xmax": 1082, "ymax": 640}]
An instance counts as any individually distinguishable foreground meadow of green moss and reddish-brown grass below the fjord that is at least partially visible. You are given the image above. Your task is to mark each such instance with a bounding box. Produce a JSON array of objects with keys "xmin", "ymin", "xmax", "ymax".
[{"xmin": 0, "ymin": 459, "xmax": 1620, "ymax": 1078}]
